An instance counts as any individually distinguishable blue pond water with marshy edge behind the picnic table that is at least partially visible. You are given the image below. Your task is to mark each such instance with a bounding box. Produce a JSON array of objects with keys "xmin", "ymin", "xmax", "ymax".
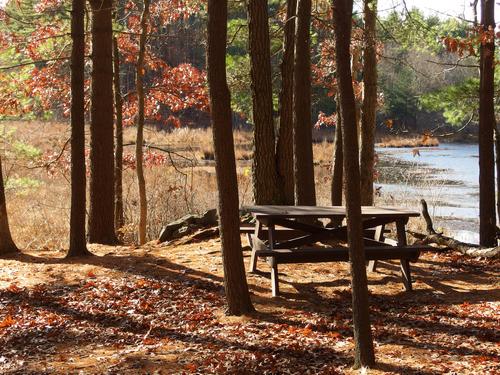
[{"xmin": 376, "ymin": 143, "xmax": 479, "ymax": 243}]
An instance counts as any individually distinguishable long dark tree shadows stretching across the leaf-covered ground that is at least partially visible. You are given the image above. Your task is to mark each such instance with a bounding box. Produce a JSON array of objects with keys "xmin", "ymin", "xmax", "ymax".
[{"xmin": 2, "ymin": 250, "xmax": 500, "ymax": 374}]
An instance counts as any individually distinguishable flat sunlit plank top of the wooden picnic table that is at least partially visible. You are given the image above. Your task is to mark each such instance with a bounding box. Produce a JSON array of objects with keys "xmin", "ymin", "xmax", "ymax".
[{"xmin": 244, "ymin": 205, "xmax": 420, "ymax": 219}]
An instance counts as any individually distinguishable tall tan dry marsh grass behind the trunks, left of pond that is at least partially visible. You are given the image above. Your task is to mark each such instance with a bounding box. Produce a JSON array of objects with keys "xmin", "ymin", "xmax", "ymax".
[{"xmin": 3, "ymin": 122, "xmax": 442, "ymax": 249}]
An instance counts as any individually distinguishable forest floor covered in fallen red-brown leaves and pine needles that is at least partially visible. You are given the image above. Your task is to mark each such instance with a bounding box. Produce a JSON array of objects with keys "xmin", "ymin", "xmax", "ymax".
[{"xmin": 0, "ymin": 239, "xmax": 500, "ymax": 374}]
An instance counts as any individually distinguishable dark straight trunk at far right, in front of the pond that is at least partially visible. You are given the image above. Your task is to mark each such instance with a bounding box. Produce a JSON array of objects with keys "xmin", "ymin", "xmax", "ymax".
[{"xmin": 479, "ymin": 0, "xmax": 497, "ymax": 247}]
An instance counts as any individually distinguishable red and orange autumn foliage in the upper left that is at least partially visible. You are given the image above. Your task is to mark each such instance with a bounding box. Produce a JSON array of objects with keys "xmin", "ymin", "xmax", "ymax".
[{"xmin": 0, "ymin": 0, "xmax": 208, "ymax": 127}]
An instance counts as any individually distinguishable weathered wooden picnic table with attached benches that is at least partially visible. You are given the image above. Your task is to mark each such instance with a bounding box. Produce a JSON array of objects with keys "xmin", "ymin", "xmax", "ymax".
[{"xmin": 242, "ymin": 205, "xmax": 429, "ymax": 296}]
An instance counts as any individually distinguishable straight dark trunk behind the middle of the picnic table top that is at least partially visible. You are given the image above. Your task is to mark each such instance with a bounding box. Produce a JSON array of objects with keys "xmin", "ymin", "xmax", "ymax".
[{"xmin": 294, "ymin": 0, "xmax": 316, "ymax": 206}]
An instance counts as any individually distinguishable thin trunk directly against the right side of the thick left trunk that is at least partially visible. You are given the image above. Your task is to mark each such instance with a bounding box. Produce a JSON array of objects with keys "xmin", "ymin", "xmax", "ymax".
[{"xmin": 113, "ymin": 38, "xmax": 125, "ymax": 231}]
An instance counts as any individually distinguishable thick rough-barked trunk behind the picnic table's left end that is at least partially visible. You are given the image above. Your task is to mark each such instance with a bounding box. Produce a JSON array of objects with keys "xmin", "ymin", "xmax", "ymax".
[{"xmin": 248, "ymin": 0, "xmax": 281, "ymax": 204}]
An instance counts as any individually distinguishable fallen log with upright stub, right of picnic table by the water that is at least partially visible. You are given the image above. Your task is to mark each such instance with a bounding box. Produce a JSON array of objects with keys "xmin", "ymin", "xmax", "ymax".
[{"xmin": 408, "ymin": 199, "xmax": 500, "ymax": 258}]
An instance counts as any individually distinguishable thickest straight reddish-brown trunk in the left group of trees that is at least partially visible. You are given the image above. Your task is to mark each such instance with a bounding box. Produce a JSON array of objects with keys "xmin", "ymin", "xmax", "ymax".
[{"xmin": 88, "ymin": 0, "xmax": 117, "ymax": 245}]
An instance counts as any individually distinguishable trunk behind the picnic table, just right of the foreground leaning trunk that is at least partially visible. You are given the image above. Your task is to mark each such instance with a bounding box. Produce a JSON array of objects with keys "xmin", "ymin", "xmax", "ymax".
[{"xmin": 360, "ymin": 0, "xmax": 377, "ymax": 206}]
